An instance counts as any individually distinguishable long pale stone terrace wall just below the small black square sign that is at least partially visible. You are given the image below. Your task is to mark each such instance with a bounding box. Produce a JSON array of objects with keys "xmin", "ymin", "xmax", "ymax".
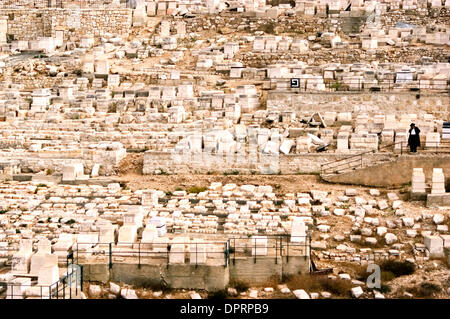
[{"xmin": 267, "ymin": 91, "xmax": 450, "ymax": 119}]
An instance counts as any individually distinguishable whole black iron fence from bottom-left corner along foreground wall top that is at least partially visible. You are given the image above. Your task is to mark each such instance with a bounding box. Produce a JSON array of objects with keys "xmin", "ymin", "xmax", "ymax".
[{"xmin": 0, "ymin": 234, "xmax": 311, "ymax": 299}]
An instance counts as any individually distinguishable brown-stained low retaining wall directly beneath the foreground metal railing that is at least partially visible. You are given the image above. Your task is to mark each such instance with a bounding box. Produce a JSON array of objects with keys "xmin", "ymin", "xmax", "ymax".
[{"xmin": 81, "ymin": 256, "xmax": 310, "ymax": 291}]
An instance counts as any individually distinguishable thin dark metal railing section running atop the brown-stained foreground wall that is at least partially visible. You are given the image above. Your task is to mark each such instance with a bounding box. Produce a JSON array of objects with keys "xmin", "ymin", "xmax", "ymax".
[{"xmin": 67, "ymin": 234, "xmax": 311, "ymax": 269}]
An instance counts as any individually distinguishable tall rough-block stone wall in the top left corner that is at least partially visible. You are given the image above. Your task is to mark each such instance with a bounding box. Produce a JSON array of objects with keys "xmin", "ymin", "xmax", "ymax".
[{"xmin": 0, "ymin": 8, "xmax": 132, "ymax": 40}]
